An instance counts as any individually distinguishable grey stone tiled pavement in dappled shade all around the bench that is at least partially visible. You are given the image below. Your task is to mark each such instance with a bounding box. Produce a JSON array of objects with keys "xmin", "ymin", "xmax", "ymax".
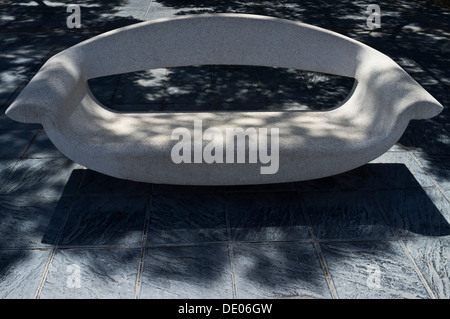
[{"xmin": 0, "ymin": 0, "xmax": 450, "ymax": 299}]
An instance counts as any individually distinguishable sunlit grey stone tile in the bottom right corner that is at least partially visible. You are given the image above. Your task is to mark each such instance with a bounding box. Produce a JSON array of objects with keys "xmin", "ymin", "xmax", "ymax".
[{"xmin": 405, "ymin": 238, "xmax": 450, "ymax": 300}]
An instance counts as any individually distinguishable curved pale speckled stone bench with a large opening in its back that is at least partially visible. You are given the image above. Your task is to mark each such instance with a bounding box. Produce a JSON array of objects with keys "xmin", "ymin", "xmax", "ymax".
[{"xmin": 6, "ymin": 14, "xmax": 442, "ymax": 185}]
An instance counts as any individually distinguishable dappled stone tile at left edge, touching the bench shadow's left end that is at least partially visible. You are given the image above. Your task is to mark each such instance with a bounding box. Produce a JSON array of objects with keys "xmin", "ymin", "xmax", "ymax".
[{"xmin": 0, "ymin": 158, "xmax": 83, "ymax": 196}]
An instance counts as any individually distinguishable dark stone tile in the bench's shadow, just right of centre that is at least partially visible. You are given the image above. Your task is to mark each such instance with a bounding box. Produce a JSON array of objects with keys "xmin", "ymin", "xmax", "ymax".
[{"xmin": 228, "ymin": 192, "xmax": 311, "ymax": 241}]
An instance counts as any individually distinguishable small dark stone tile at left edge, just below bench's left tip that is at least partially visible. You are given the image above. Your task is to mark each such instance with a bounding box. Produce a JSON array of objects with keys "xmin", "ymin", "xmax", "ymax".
[{"xmin": 0, "ymin": 130, "xmax": 36, "ymax": 159}]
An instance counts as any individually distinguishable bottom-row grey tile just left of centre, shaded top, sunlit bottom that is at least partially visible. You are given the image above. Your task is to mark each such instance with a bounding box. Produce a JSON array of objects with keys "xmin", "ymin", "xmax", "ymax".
[{"xmin": 140, "ymin": 245, "xmax": 233, "ymax": 299}]
